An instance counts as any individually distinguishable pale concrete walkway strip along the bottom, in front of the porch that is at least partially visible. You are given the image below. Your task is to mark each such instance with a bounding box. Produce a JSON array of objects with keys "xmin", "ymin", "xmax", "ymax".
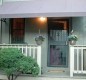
[{"xmin": 0, "ymin": 75, "xmax": 86, "ymax": 80}]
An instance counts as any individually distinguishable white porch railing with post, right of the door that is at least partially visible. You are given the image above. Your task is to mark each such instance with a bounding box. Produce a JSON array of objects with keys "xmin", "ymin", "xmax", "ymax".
[{"xmin": 69, "ymin": 45, "xmax": 86, "ymax": 77}]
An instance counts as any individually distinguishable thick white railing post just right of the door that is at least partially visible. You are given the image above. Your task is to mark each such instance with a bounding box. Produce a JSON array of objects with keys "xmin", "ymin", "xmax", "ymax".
[{"xmin": 69, "ymin": 46, "xmax": 74, "ymax": 77}]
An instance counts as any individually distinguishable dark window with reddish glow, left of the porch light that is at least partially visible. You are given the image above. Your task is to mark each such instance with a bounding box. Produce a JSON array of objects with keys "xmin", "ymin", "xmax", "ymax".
[{"xmin": 11, "ymin": 18, "xmax": 25, "ymax": 43}]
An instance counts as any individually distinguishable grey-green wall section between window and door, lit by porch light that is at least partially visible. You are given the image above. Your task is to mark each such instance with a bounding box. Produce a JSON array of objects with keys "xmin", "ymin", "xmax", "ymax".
[{"xmin": 25, "ymin": 18, "xmax": 48, "ymax": 71}]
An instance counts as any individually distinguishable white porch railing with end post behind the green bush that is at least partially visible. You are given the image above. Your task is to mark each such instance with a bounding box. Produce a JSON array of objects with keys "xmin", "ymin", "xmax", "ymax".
[{"xmin": 0, "ymin": 44, "xmax": 41, "ymax": 75}]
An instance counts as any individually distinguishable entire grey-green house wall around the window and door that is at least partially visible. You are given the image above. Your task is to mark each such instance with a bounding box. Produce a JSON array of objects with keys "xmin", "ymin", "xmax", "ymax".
[{"xmin": 0, "ymin": 17, "xmax": 86, "ymax": 73}]
